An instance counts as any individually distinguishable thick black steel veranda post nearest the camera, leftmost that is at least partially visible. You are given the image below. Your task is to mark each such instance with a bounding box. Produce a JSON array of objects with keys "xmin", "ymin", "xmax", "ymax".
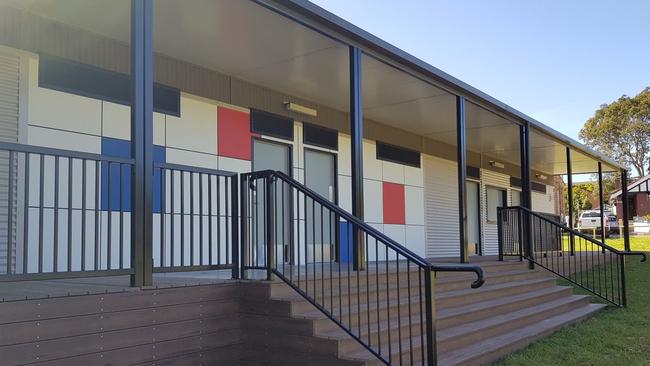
[{"xmin": 131, "ymin": 0, "xmax": 153, "ymax": 286}]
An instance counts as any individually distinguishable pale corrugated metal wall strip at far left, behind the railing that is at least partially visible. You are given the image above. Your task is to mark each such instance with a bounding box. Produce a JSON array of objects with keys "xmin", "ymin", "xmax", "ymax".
[{"xmin": 0, "ymin": 51, "xmax": 20, "ymax": 273}]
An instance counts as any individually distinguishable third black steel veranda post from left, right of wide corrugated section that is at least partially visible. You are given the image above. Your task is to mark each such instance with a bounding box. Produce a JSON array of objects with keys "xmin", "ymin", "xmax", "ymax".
[{"xmin": 456, "ymin": 96, "xmax": 469, "ymax": 263}]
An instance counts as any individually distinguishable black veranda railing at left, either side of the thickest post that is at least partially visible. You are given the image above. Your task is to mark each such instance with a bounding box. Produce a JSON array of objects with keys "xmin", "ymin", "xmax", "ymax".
[{"xmin": 0, "ymin": 142, "xmax": 239, "ymax": 281}]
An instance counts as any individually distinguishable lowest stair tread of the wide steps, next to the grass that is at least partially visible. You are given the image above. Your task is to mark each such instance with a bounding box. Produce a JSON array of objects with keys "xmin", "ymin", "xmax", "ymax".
[{"xmin": 438, "ymin": 303, "xmax": 607, "ymax": 365}]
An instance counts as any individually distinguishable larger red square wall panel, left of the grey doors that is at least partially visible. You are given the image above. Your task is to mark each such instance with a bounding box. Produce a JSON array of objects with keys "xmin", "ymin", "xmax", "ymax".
[{"xmin": 217, "ymin": 107, "xmax": 253, "ymax": 160}]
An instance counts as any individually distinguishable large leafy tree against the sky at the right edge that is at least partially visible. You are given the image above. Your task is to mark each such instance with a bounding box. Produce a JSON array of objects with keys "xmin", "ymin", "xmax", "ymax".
[{"xmin": 580, "ymin": 87, "xmax": 650, "ymax": 176}]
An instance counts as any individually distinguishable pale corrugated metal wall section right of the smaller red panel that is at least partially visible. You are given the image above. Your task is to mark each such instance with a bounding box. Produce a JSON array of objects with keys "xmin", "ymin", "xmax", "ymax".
[{"xmin": 422, "ymin": 155, "xmax": 460, "ymax": 257}]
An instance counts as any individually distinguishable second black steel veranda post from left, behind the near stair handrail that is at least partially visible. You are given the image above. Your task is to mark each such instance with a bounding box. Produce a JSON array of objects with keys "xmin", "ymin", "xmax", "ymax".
[{"xmin": 350, "ymin": 47, "xmax": 365, "ymax": 270}]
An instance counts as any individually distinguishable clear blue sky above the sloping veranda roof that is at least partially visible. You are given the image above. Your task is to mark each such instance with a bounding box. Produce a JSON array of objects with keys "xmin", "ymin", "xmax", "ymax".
[{"xmin": 312, "ymin": 0, "xmax": 650, "ymax": 138}]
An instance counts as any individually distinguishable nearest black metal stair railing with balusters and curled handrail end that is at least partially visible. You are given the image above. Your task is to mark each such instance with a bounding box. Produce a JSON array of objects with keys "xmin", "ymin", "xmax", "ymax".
[{"xmin": 241, "ymin": 170, "xmax": 485, "ymax": 365}]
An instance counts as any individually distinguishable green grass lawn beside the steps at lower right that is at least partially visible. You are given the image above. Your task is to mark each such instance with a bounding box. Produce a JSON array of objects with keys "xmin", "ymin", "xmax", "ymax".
[{"xmin": 495, "ymin": 237, "xmax": 650, "ymax": 366}]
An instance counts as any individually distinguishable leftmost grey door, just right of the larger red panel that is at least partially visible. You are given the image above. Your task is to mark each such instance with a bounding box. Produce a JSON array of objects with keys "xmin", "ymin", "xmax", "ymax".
[{"xmin": 253, "ymin": 139, "xmax": 291, "ymax": 265}]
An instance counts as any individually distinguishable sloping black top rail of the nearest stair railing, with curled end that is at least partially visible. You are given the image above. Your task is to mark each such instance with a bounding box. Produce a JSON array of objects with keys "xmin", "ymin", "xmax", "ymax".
[{"xmin": 242, "ymin": 170, "xmax": 485, "ymax": 288}]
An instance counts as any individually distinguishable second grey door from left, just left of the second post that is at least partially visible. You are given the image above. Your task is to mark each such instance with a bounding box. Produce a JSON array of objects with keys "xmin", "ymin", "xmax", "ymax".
[{"xmin": 305, "ymin": 149, "xmax": 336, "ymax": 262}]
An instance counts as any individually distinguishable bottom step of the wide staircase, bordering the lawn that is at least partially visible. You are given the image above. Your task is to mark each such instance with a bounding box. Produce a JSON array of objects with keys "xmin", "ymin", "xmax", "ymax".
[{"xmin": 438, "ymin": 304, "xmax": 606, "ymax": 366}]
